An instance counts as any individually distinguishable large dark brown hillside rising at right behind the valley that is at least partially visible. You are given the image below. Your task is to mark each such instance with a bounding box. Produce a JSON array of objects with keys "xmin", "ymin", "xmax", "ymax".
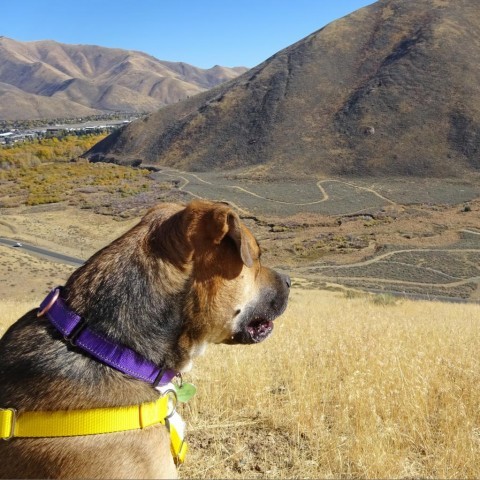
[{"xmin": 87, "ymin": 0, "xmax": 480, "ymax": 177}]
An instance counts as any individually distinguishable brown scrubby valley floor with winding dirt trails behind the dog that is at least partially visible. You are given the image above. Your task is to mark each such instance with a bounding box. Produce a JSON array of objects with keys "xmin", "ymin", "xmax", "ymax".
[{"xmin": 0, "ymin": 171, "xmax": 480, "ymax": 302}]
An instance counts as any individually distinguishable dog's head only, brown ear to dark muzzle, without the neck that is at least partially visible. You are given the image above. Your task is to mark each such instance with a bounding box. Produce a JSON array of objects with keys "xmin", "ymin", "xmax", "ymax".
[{"xmin": 147, "ymin": 200, "xmax": 290, "ymax": 344}]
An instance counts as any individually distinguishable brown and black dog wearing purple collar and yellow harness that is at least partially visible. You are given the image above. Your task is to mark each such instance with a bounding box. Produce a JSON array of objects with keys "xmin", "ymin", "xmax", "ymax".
[{"xmin": 0, "ymin": 200, "xmax": 291, "ymax": 478}]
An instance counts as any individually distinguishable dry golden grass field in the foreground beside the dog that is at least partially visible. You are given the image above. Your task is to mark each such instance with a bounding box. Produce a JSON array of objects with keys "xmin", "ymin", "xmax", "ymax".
[{"xmin": 0, "ymin": 289, "xmax": 480, "ymax": 478}]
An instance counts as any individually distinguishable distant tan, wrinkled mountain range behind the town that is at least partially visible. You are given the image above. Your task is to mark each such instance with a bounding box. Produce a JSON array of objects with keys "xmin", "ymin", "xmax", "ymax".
[{"xmin": 0, "ymin": 37, "xmax": 247, "ymax": 120}]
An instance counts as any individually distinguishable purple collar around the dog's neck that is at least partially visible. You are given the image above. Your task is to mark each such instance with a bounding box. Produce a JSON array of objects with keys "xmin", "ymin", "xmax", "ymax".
[{"xmin": 37, "ymin": 287, "xmax": 177, "ymax": 387}]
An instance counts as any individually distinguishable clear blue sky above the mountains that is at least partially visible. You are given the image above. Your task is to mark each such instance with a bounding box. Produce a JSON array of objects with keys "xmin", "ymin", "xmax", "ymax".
[{"xmin": 0, "ymin": 0, "xmax": 374, "ymax": 68}]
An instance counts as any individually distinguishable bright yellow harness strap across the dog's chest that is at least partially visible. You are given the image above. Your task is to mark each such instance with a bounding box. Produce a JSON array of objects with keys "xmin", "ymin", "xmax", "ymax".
[{"xmin": 0, "ymin": 395, "xmax": 187, "ymax": 463}]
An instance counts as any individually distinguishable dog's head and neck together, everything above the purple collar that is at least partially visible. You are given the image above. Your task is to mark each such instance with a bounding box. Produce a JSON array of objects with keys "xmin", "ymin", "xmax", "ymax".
[{"xmin": 63, "ymin": 200, "xmax": 290, "ymax": 369}]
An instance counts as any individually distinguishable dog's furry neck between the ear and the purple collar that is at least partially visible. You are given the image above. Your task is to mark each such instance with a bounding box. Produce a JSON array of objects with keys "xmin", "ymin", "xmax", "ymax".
[{"xmin": 64, "ymin": 227, "xmax": 198, "ymax": 371}]
